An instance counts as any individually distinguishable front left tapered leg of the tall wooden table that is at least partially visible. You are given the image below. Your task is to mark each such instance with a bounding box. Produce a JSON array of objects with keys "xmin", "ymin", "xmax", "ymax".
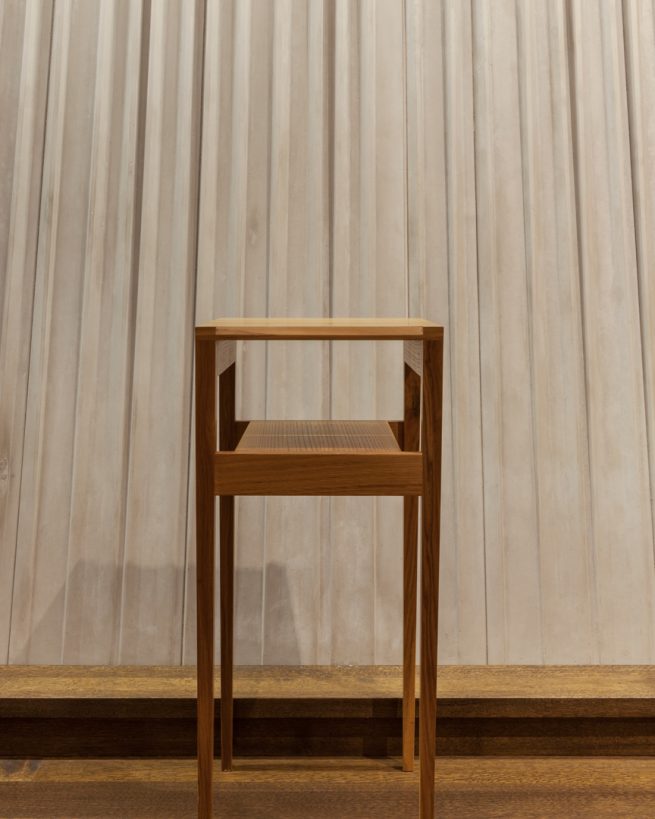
[{"xmin": 196, "ymin": 340, "xmax": 216, "ymax": 819}]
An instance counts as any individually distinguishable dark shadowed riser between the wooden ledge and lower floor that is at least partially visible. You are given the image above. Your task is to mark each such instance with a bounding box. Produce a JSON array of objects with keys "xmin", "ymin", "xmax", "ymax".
[{"xmin": 1, "ymin": 712, "xmax": 655, "ymax": 768}]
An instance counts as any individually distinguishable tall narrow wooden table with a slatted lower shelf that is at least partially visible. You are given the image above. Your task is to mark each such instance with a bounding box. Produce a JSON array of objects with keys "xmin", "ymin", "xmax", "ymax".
[{"xmin": 195, "ymin": 318, "xmax": 443, "ymax": 819}]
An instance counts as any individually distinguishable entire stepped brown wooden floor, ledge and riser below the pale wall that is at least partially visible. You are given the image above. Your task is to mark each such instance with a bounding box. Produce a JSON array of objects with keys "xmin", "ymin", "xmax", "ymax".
[{"xmin": 0, "ymin": 666, "xmax": 655, "ymax": 819}]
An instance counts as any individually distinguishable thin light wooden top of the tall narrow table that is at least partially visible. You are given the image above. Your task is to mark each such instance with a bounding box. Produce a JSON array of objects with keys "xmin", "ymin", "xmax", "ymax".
[{"xmin": 196, "ymin": 318, "xmax": 443, "ymax": 340}]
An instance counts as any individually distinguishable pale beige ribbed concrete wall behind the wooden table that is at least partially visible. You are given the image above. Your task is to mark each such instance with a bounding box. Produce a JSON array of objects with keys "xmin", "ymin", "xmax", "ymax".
[{"xmin": 0, "ymin": 0, "xmax": 655, "ymax": 664}]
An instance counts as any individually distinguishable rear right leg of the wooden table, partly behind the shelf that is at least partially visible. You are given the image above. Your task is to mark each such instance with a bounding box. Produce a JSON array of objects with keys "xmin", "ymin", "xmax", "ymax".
[{"xmin": 403, "ymin": 364, "xmax": 421, "ymax": 771}]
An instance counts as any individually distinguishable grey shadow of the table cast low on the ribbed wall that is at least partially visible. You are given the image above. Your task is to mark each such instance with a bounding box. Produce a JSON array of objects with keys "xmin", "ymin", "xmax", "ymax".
[{"xmin": 10, "ymin": 549, "xmax": 300, "ymax": 665}]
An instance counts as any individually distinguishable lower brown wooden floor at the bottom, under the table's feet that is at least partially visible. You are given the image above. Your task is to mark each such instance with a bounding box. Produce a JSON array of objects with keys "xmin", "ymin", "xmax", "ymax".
[{"xmin": 0, "ymin": 757, "xmax": 655, "ymax": 819}]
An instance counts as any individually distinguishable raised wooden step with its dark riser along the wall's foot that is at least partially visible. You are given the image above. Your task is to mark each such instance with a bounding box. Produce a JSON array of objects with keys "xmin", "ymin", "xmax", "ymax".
[{"xmin": 0, "ymin": 666, "xmax": 655, "ymax": 758}]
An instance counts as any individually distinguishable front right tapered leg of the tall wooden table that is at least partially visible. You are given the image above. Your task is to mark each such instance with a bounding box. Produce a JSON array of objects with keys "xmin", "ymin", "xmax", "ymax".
[{"xmin": 419, "ymin": 339, "xmax": 443, "ymax": 819}]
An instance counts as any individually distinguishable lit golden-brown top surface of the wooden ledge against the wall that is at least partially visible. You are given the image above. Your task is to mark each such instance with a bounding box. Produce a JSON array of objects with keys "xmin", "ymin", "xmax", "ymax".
[{"xmin": 5, "ymin": 665, "xmax": 655, "ymax": 717}]
